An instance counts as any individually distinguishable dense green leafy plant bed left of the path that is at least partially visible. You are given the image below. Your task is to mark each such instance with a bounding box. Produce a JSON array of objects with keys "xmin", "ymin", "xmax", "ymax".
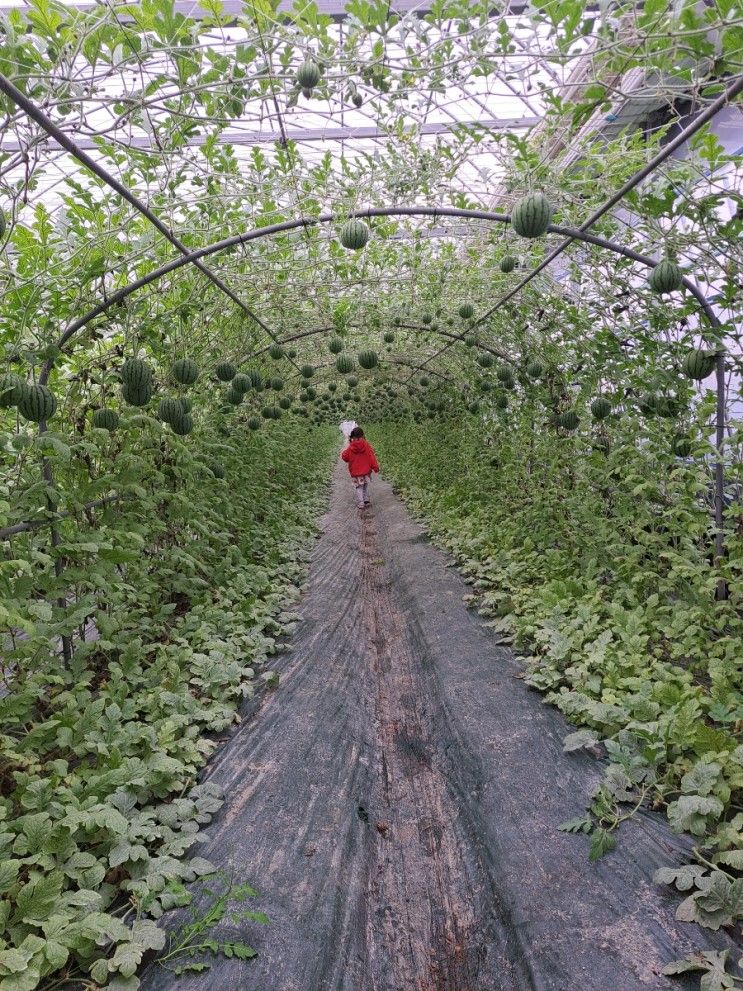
[{"xmin": 0, "ymin": 415, "xmax": 335, "ymax": 991}]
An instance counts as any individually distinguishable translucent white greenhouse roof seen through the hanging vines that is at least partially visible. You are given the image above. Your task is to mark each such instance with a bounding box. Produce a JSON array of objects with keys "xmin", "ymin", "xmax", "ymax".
[{"xmin": 0, "ymin": 0, "xmax": 739, "ymax": 386}]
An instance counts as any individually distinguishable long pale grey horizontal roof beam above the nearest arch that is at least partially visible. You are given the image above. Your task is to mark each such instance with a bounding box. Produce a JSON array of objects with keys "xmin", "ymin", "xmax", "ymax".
[{"xmin": 0, "ymin": 116, "xmax": 540, "ymax": 155}]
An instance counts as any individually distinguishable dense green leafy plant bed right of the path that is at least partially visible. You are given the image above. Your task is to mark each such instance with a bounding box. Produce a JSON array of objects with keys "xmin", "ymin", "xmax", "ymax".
[{"xmin": 373, "ymin": 423, "xmax": 743, "ymax": 988}]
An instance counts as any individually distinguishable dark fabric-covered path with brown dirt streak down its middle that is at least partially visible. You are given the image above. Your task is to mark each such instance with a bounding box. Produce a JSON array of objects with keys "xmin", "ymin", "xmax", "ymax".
[{"xmin": 143, "ymin": 466, "xmax": 728, "ymax": 991}]
